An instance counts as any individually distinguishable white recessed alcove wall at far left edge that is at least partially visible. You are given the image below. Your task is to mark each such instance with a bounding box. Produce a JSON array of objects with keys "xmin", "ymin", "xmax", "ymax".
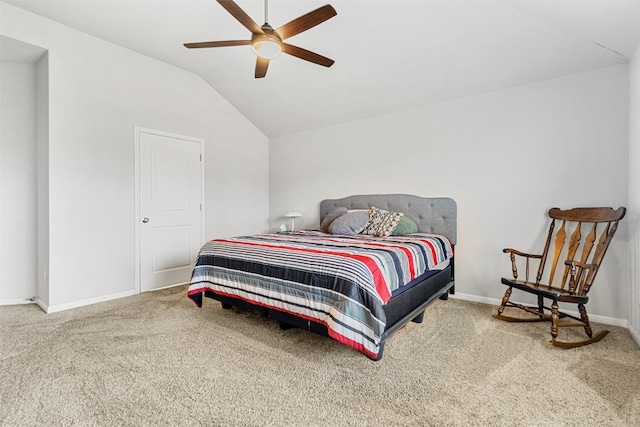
[{"xmin": 0, "ymin": 62, "xmax": 37, "ymax": 304}]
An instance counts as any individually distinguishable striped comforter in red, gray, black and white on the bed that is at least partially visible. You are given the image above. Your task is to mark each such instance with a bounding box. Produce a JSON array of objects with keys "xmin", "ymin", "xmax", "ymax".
[{"xmin": 188, "ymin": 231, "xmax": 453, "ymax": 359}]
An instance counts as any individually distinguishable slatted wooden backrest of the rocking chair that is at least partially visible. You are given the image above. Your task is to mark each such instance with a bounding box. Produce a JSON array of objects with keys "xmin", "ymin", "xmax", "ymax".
[{"xmin": 536, "ymin": 207, "xmax": 626, "ymax": 295}]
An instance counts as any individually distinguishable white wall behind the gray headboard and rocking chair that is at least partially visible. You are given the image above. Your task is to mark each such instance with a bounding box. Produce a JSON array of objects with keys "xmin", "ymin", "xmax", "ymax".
[{"xmin": 269, "ymin": 65, "xmax": 629, "ymax": 325}]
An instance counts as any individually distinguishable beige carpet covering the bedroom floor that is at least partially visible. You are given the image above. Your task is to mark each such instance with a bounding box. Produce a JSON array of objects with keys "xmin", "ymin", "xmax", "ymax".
[{"xmin": 0, "ymin": 287, "xmax": 640, "ymax": 426}]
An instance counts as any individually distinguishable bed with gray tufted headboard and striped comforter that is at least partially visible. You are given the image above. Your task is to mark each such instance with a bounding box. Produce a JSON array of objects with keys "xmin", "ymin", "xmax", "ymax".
[{"xmin": 188, "ymin": 194, "xmax": 457, "ymax": 360}]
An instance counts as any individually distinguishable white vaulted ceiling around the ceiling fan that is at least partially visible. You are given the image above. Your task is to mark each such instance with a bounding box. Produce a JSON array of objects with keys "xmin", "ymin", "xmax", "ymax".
[{"xmin": 3, "ymin": 0, "xmax": 640, "ymax": 136}]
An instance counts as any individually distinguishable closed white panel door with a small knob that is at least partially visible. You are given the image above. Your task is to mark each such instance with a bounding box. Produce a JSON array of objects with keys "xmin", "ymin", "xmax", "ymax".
[{"xmin": 136, "ymin": 128, "xmax": 203, "ymax": 291}]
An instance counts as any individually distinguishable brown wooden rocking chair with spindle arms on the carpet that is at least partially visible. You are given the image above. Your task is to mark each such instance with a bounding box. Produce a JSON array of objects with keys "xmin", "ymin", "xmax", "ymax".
[{"xmin": 493, "ymin": 207, "xmax": 626, "ymax": 348}]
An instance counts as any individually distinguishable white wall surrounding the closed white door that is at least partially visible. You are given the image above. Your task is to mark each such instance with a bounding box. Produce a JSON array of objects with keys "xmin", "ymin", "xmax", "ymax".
[{"xmin": 0, "ymin": 3, "xmax": 269, "ymax": 311}]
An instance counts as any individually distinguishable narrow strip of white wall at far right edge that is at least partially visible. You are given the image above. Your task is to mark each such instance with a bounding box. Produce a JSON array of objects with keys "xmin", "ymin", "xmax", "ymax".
[{"xmin": 627, "ymin": 48, "xmax": 640, "ymax": 345}]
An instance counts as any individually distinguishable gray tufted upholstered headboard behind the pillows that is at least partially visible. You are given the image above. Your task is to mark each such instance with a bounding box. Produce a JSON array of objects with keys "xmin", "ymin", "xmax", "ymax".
[{"xmin": 320, "ymin": 194, "xmax": 457, "ymax": 245}]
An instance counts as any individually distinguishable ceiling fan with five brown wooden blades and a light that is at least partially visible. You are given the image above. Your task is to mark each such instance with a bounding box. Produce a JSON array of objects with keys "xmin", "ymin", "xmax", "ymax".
[{"xmin": 184, "ymin": 0, "xmax": 337, "ymax": 79}]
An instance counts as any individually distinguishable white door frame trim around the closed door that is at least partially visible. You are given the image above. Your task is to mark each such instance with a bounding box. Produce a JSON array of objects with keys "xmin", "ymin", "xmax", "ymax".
[{"xmin": 133, "ymin": 126, "xmax": 205, "ymax": 294}]
